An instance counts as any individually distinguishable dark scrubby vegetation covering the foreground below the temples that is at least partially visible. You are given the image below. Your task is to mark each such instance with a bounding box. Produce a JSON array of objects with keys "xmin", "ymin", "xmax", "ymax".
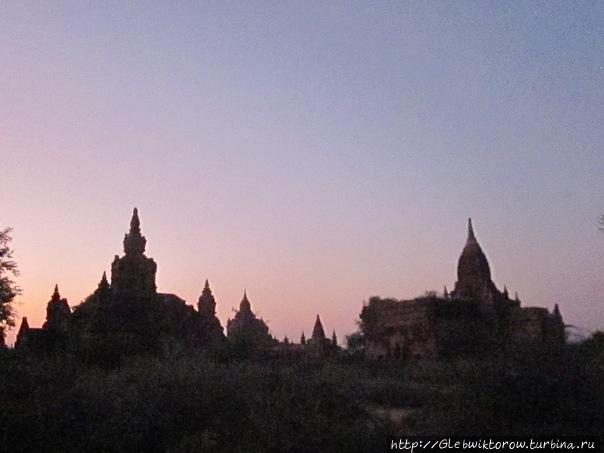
[{"xmin": 0, "ymin": 334, "xmax": 604, "ymax": 452}]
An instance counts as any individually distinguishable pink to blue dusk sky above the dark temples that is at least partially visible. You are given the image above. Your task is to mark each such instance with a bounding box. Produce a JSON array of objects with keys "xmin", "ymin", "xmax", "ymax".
[{"xmin": 0, "ymin": 0, "xmax": 604, "ymax": 342}]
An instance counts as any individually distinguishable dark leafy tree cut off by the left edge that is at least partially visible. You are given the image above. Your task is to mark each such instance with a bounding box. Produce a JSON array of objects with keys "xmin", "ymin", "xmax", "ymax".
[{"xmin": 0, "ymin": 228, "xmax": 21, "ymax": 346}]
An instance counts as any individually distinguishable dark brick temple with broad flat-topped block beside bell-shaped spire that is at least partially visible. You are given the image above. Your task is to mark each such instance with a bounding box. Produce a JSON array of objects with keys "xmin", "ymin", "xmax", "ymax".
[{"xmin": 360, "ymin": 220, "xmax": 565, "ymax": 359}]
